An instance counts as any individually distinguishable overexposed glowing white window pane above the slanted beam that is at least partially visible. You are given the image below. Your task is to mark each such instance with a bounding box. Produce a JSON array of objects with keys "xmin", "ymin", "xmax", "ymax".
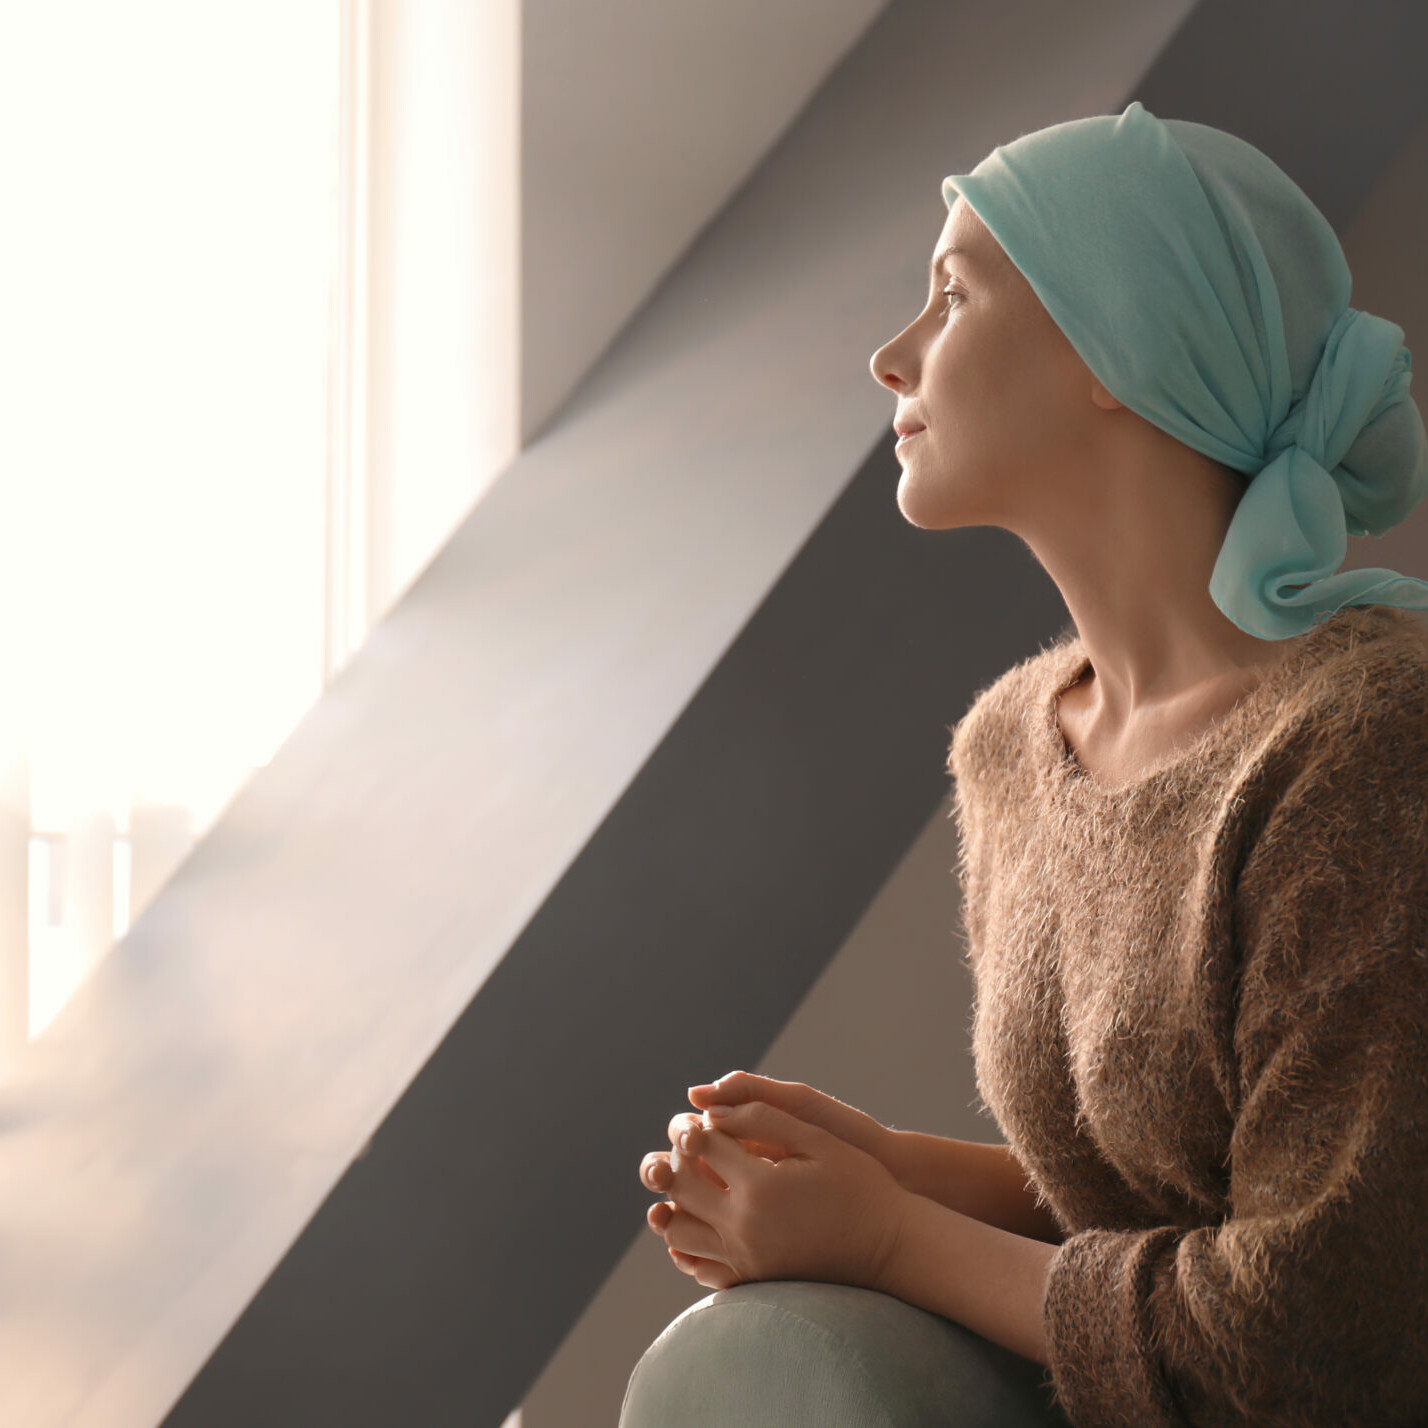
[{"xmin": 0, "ymin": 0, "xmax": 340, "ymax": 1035}]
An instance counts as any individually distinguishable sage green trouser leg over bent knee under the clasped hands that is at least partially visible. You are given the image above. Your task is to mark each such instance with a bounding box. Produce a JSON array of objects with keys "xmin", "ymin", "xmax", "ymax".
[{"xmin": 620, "ymin": 1279, "xmax": 1070, "ymax": 1428}]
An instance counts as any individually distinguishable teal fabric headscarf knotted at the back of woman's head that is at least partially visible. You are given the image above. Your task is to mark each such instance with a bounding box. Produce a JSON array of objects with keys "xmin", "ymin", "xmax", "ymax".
[{"xmin": 942, "ymin": 101, "xmax": 1428, "ymax": 640}]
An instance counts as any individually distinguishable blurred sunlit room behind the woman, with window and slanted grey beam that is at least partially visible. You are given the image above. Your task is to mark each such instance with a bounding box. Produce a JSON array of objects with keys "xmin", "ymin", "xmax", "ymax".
[{"xmin": 0, "ymin": 0, "xmax": 1428, "ymax": 1428}]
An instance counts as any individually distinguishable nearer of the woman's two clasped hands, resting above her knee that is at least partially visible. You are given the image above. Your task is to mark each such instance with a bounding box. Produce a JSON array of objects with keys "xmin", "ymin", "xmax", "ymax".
[{"xmin": 648, "ymin": 1101, "xmax": 910, "ymax": 1289}]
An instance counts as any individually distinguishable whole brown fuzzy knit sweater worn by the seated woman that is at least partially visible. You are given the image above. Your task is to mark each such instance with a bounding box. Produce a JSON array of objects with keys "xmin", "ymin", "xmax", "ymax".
[{"xmin": 948, "ymin": 605, "xmax": 1428, "ymax": 1428}]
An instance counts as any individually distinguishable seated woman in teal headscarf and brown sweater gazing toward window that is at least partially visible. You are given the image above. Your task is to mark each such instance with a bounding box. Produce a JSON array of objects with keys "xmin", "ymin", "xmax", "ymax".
[{"xmin": 621, "ymin": 103, "xmax": 1428, "ymax": 1428}]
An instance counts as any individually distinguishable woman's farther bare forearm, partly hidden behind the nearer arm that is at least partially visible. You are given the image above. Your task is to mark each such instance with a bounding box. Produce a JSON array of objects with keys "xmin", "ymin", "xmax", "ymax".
[{"xmin": 888, "ymin": 1131, "xmax": 1064, "ymax": 1244}]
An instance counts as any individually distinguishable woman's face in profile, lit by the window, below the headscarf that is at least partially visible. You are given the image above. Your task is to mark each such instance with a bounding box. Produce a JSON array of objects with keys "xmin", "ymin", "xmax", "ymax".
[{"xmin": 870, "ymin": 196, "xmax": 1095, "ymax": 530}]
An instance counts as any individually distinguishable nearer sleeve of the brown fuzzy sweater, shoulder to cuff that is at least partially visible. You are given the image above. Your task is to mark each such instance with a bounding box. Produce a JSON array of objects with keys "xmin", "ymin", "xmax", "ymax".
[{"xmin": 1044, "ymin": 695, "xmax": 1428, "ymax": 1428}]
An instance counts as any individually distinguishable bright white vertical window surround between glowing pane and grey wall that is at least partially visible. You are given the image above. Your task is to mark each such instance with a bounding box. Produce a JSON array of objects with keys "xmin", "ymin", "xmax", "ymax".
[{"xmin": 358, "ymin": 0, "xmax": 521, "ymax": 634}]
